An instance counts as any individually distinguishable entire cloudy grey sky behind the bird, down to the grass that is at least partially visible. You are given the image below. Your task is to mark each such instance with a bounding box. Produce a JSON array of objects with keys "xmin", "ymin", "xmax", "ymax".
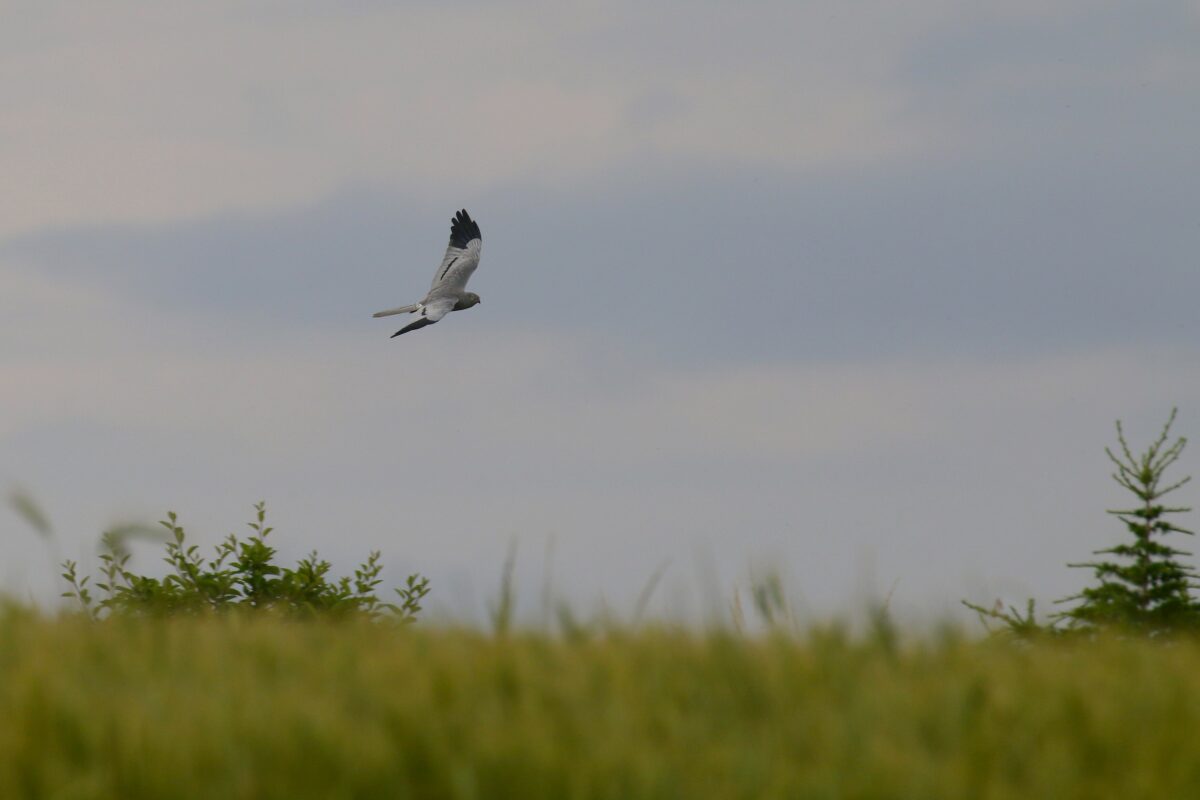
[{"xmin": 0, "ymin": 0, "xmax": 1200, "ymax": 619}]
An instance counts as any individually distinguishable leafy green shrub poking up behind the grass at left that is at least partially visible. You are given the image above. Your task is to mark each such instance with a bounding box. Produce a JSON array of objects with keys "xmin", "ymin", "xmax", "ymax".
[{"xmin": 62, "ymin": 503, "xmax": 430, "ymax": 622}]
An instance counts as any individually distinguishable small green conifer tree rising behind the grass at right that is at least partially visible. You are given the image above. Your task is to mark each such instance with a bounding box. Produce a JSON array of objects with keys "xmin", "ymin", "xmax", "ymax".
[{"xmin": 1056, "ymin": 409, "xmax": 1200, "ymax": 633}]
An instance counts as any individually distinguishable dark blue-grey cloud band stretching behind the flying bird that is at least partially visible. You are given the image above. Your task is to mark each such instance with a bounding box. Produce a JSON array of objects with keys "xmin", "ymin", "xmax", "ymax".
[{"xmin": 11, "ymin": 152, "xmax": 1200, "ymax": 365}]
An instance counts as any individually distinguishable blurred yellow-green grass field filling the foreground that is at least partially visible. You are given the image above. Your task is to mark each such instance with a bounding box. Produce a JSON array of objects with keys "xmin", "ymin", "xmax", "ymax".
[{"xmin": 0, "ymin": 609, "xmax": 1200, "ymax": 800}]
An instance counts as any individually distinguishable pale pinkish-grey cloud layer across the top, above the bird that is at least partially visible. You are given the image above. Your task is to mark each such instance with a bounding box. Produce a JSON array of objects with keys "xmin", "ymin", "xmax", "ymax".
[{"xmin": 0, "ymin": 0, "xmax": 1200, "ymax": 244}]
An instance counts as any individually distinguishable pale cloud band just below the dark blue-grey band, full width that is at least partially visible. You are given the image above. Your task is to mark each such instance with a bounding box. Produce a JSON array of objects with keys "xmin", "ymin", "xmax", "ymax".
[{"xmin": 7, "ymin": 260, "xmax": 1195, "ymax": 464}]
